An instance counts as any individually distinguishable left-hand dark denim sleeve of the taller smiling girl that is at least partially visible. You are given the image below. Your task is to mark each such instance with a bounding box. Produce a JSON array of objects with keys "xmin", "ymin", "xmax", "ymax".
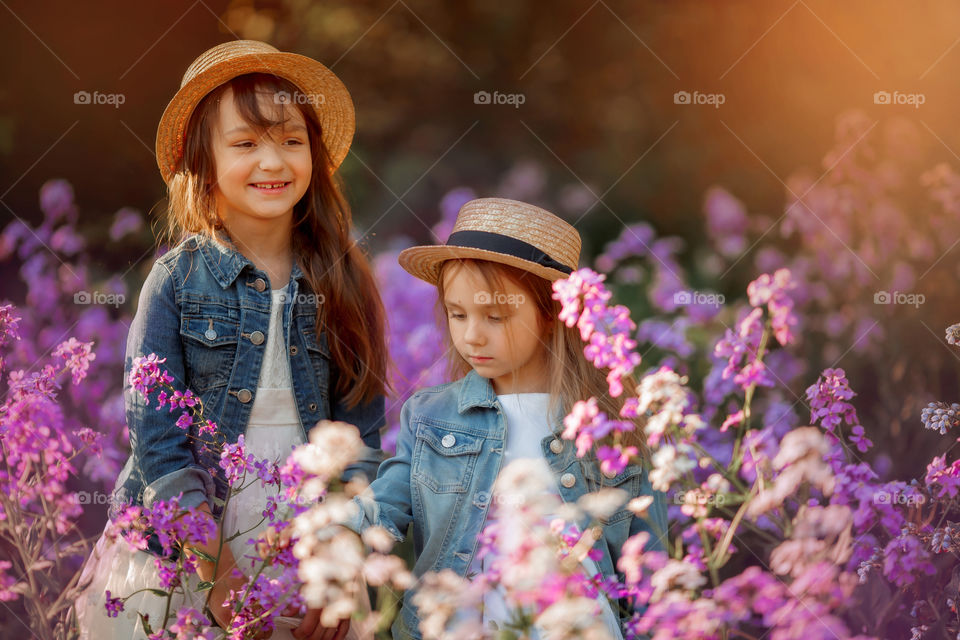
[{"xmin": 123, "ymin": 262, "xmax": 214, "ymax": 508}]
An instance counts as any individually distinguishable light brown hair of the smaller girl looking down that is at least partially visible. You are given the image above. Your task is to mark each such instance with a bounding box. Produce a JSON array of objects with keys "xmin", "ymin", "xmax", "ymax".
[{"xmin": 437, "ymin": 259, "xmax": 650, "ymax": 460}]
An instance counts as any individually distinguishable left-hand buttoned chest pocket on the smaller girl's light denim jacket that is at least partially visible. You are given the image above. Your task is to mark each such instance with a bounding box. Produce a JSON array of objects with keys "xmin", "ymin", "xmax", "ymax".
[{"xmin": 411, "ymin": 418, "xmax": 483, "ymax": 493}]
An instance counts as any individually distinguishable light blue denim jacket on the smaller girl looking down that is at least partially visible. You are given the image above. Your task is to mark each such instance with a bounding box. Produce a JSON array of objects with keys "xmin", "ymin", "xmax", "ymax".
[{"xmin": 345, "ymin": 371, "xmax": 667, "ymax": 640}]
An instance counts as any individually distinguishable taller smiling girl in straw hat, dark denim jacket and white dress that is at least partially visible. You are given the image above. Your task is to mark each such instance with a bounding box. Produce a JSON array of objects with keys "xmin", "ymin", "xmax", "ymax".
[{"xmin": 77, "ymin": 40, "xmax": 386, "ymax": 640}]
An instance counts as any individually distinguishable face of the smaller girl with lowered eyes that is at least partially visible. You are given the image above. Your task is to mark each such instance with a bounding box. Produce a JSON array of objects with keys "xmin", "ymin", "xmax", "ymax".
[{"xmin": 443, "ymin": 262, "xmax": 547, "ymax": 394}]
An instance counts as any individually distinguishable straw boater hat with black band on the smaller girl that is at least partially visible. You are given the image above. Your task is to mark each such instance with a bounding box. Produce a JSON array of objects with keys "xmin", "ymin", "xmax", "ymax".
[{"xmin": 397, "ymin": 198, "xmax": 580, "ymax": 285}]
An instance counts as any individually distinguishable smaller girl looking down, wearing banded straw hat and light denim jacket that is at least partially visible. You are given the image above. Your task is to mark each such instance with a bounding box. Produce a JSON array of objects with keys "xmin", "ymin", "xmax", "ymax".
[{"xmin": 346, "ymin": 199, "xmax": 666, "ymax": 640}]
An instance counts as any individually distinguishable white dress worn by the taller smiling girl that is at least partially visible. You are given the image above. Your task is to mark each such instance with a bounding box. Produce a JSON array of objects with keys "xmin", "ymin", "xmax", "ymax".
[{"xmin": 76, "ymin": 287, "xmax": 303, "ymax": 640}]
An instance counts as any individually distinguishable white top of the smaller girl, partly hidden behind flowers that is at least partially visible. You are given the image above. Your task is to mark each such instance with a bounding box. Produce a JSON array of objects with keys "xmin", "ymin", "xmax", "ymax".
[{"xmin": 471, "ymin": 393, "xmax": 623, "ymax": 640}]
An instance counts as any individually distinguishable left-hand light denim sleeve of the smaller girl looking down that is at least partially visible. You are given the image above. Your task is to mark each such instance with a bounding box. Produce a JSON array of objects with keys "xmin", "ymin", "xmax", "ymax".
[{"xmin": 344, "ymin": 396, "xmax": 416, "ymax": 541}]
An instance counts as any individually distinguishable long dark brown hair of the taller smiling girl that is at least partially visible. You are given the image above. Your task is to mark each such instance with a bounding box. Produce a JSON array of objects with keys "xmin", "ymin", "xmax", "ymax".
[{"xmin": 166, "ymin": 73, "xmax": 388, "ymax": 407}]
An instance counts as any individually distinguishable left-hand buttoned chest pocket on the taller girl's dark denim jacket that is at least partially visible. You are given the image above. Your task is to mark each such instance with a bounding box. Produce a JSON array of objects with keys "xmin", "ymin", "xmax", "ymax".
[{"xmin": 180, "ymin": 303, "xmax": 240, "ymax": 393}]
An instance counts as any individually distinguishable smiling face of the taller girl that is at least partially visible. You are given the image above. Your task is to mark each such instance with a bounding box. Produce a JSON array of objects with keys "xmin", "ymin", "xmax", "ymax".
[{"xmin": 211, "ymin": 89, "xmax": 313, "ymax": 231}]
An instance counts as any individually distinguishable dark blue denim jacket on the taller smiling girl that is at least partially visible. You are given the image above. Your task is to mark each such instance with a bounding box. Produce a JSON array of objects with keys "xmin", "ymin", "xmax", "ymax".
[{"xmin": 111, "ymin": 235, "xmax": 385, "ymax": 552}]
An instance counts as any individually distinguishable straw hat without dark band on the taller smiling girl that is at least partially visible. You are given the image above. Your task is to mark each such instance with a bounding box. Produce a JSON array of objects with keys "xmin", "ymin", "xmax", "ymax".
[{"xmin": 156, "ymin": 40, "xmax": 355, "ymax": 183}]
